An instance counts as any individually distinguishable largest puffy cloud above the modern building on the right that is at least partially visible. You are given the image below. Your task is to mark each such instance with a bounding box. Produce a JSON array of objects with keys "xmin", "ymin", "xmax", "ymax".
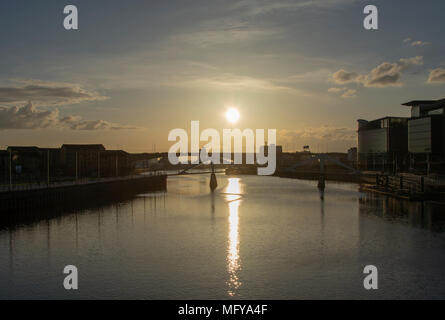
[{"xmin": 331, "ymin": 56, "xmax": 423, "ymax": 88}]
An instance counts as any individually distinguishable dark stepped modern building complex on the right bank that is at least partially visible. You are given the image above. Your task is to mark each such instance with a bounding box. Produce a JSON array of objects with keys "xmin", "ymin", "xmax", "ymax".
[{"xmin": 357, "ymin": 99, "xmax": 445, "ymax": 173}]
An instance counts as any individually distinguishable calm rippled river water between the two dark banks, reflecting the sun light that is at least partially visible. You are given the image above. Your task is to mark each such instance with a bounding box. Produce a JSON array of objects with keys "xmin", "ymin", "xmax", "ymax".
[{"xmin": 0, "ymin": 175, "xmax": 445, "ymax": 299}]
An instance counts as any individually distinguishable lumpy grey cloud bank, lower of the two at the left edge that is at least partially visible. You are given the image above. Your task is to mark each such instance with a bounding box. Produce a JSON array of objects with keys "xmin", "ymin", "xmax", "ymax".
[{"xmin": 0, "ymin": 102, "xmax": 136, "ymax": 130}]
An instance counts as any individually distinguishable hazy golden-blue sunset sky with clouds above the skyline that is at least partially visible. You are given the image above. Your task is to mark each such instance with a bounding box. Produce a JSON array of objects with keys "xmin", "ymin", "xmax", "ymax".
[{"xmin": 0, "ymin": 0, "xmax": 445, "ymax": 152}]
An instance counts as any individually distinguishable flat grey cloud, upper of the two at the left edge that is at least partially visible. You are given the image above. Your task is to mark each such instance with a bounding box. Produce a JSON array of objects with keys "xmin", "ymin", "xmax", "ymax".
[{"xmin": 0, "ymin": 80, "xmax": 107, "ymax": 106}]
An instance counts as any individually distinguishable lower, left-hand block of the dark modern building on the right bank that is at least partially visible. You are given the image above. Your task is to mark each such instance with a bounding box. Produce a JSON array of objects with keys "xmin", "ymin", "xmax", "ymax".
[{"xmin": 357, "ymin": 117, "xmax": 409, "ymax": 170}]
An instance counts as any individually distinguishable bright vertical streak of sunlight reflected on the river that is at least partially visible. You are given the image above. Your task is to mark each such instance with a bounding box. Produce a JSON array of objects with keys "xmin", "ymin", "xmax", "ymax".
[{"xmin": 225, "ymin": 178, "xmax": 242, "ymax": 297}]
